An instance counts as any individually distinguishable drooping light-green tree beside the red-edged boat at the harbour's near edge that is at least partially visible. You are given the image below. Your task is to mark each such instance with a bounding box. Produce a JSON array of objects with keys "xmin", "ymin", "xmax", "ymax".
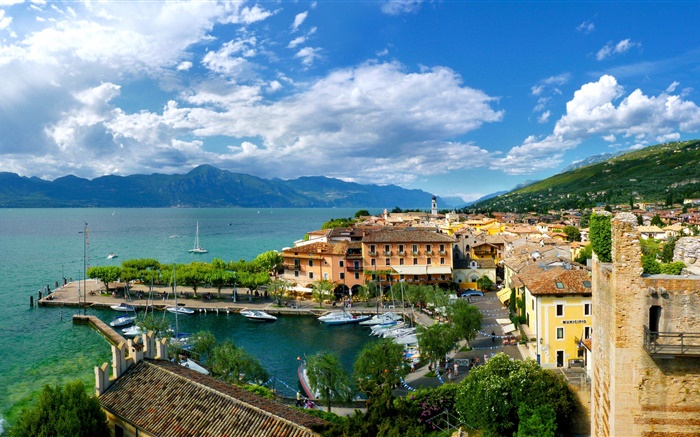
[{"xmin": 306, "ymin": 352, "xmax": 352, "ymax": 412}]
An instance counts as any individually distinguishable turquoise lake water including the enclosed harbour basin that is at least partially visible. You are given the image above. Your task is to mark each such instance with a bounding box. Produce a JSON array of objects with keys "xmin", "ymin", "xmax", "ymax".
[{"xmin": 0, "ymin": 208, "xmax": 378, "ymax": 434}]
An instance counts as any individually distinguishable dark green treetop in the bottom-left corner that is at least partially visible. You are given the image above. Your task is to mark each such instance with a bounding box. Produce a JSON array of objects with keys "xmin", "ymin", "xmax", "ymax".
[{"xmin": 9, "ymin": 381, "xmax": 110, "ymax": 437}]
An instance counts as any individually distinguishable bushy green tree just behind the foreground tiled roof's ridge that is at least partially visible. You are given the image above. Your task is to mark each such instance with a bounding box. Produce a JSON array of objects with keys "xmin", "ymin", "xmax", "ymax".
[{"xmin": 211, "ymin": 341, "xmax": 269, "ymax": 385}]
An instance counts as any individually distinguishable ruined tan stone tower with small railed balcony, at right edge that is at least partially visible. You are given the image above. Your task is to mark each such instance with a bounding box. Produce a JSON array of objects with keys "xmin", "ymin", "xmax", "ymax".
[{"xmin": 591, "ymin": 213, "xmax": 700, "ymax": 437}]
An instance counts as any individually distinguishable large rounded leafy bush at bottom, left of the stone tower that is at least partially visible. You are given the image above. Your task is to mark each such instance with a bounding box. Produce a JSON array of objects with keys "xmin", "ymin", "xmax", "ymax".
[{"xmin": 456, "ymin": 353, "xmax": 578, "ymax": 436}]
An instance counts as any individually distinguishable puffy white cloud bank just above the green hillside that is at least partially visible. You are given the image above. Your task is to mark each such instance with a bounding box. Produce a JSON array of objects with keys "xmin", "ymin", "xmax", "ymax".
[{"xmin": 492, "ymin": 75, "xmax": 700, "ymax": 174}]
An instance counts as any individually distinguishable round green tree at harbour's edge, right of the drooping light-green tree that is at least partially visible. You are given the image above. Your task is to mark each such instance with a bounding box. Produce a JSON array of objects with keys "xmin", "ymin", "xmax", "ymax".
[{"xmin": 353, "ymin": 339, "xmax": 405, "ymax": 396}]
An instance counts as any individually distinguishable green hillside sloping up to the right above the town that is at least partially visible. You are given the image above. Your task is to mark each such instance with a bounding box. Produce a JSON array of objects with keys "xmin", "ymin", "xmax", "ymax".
[{"xmin": 469, "ymin": 140, "xmax": 700, "ymax": 212}]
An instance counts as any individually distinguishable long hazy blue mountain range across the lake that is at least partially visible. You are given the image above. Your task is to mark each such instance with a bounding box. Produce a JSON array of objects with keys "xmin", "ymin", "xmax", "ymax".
[{"xmin": 0, "ymin": 165, "xmax": 440, "ymax": 210}]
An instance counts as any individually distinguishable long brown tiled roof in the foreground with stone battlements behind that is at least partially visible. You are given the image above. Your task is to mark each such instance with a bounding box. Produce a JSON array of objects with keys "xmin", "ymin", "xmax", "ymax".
[{"xmin": 99, "ymin": 360, "xmax": 327, "ymax": 437}]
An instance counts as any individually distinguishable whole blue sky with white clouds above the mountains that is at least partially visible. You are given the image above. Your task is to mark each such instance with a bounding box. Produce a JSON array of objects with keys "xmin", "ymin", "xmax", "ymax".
[{"xmin": 0, "ymin": 0, "xmax": 700, "ymax": 201}]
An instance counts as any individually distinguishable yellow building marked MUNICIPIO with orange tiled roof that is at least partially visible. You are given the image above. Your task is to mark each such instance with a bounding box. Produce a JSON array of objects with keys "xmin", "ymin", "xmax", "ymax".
[{"xmin": 510, "ymin": 263, "xmax": 592, "ymax": 367}]
